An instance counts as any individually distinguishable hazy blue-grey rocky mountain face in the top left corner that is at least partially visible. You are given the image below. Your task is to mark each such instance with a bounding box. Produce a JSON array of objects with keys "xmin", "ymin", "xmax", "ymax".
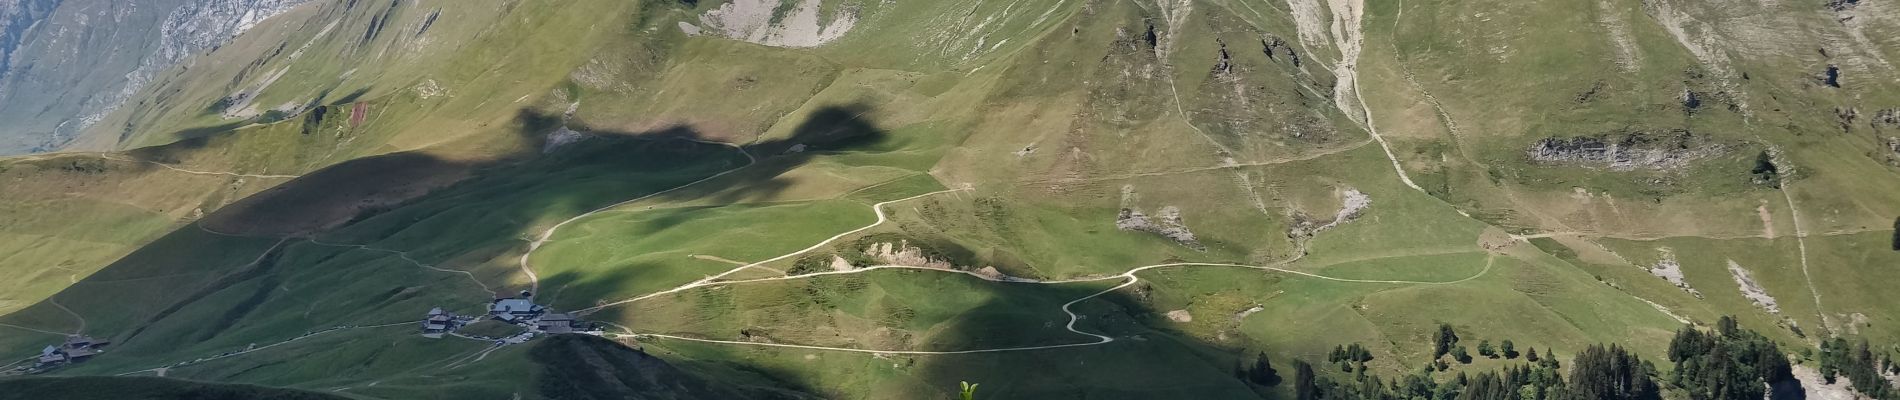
[{"xmin": 0, "ymin": 0, "xmax": 306, "ymax": 154}]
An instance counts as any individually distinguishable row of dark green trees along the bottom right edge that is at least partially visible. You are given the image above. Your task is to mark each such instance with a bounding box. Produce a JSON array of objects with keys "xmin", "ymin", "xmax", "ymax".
[{"xmin": 1235, "ymin": 317, "xmax": 1900, "ymax": 400}]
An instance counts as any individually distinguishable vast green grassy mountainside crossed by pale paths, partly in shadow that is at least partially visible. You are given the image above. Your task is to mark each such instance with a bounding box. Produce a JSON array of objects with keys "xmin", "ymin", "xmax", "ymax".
[{"xmin": 0, "ymin": 0, "xmax": 1900, "ymax": 398}]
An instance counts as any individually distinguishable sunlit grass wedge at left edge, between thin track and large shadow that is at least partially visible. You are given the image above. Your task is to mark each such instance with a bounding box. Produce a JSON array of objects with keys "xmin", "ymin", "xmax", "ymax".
[{"xmin": 0, "ymin": 154, "xmax": 281, "ymax": 313}]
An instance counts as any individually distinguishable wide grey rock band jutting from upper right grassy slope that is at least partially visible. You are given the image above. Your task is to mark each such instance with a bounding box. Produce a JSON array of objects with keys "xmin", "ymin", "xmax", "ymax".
[{"xmin": 1526, "ymin": 129, "xmax": 1729, "ymax": 171}]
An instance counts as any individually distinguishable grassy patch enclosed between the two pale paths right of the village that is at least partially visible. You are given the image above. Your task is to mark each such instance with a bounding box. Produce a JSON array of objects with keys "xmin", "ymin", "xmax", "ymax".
[{"xmin": 602, "ymin": 271, "xmax": 1119, "ymax": 351}]
